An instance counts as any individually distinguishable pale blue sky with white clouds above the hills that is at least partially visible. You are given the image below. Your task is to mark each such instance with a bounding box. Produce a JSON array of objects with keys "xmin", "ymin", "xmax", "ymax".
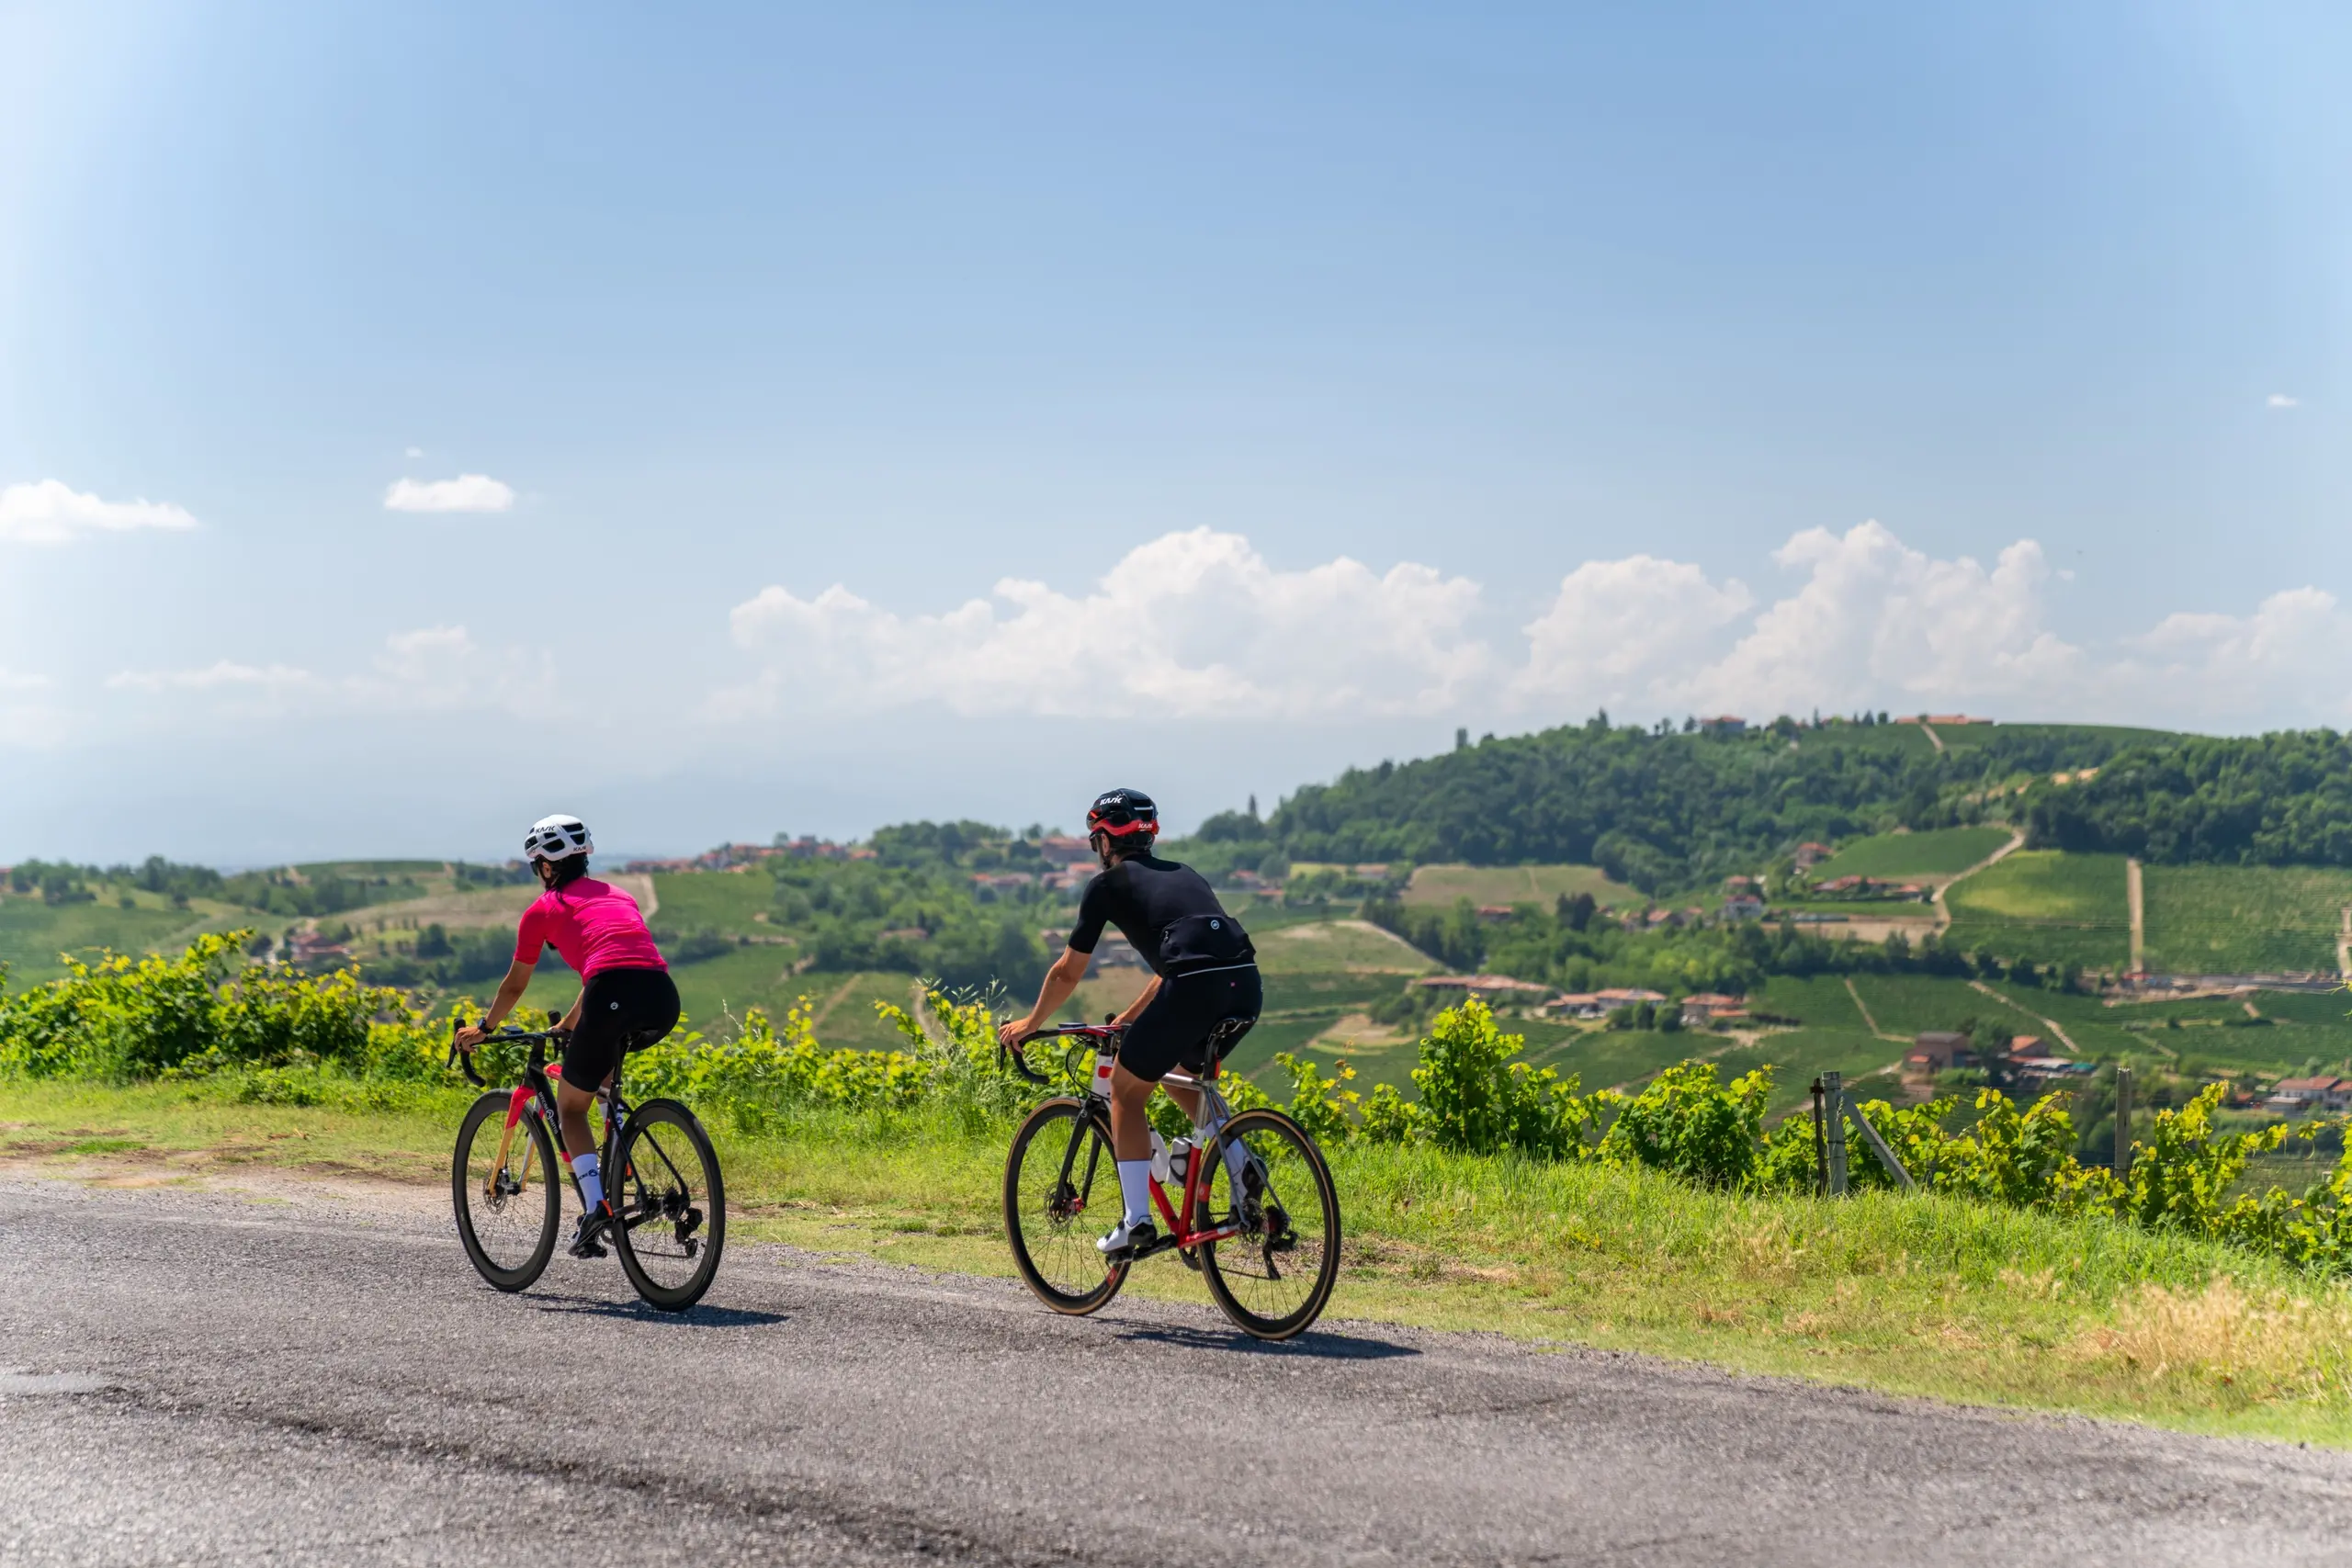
[{"xmin": 0, "ymin": 3, "xmax": 2352, "ymax": 861}]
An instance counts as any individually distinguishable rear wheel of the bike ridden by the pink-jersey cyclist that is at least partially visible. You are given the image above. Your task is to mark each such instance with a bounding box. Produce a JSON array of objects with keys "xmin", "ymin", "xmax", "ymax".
[{"xmin": 606, "ymin": 1100, "xmax": 727, "ymax": 1312}]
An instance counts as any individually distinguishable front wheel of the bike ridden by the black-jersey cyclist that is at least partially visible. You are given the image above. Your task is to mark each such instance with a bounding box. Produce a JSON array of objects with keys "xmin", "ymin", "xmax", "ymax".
[{"xmin": 1004, "ymin": 1098, "xmax": 1126, "ymax": 1316}]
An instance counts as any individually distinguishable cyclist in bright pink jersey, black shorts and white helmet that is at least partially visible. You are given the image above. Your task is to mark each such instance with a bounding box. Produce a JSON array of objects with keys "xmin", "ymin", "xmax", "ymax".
[{"xmin": 457, "ymin": 816, "xmax": 677, "ymax": 1258}]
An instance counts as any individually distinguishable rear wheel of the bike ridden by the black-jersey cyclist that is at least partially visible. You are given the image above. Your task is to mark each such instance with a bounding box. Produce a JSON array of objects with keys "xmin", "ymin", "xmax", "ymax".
[{"xmin": 1194, "ymin": 1110, "xmax": 1340, "ymax": 1340}]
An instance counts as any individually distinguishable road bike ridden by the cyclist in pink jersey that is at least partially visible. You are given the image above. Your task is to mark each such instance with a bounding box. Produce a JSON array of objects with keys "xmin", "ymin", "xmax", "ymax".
[{"xmin": 449, "ymin": 1025, "xmax": 727, "ymax": 1312}]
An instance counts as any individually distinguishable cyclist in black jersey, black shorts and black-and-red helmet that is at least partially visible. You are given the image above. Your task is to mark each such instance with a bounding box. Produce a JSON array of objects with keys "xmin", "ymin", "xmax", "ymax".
[{"xmin": 1000, "ymin": 790, "xmax": 1265, "ymax": 1258}]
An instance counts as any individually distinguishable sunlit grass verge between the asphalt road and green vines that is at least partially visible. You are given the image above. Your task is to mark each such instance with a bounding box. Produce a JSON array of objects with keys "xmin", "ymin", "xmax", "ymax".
[{"xmin": 0, "ymin": 1084, "xmax": 2352, "ymax": 1446}]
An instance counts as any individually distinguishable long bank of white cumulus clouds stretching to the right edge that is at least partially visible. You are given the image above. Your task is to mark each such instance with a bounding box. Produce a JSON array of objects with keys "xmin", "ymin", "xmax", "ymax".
[{"xmin": 708, "ymin": 522, "xmax": 2352, "ymax": 728}]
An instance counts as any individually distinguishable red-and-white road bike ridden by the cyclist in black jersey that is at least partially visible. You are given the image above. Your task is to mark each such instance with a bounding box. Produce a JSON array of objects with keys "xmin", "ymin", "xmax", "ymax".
[{"xmin": 1004, "ymin": 1021, "xmax": 1340, "ymax": 1340}]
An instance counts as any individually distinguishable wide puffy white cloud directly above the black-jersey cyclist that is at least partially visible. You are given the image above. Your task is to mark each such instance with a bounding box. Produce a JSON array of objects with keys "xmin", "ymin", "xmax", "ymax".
[{"xmin": 718, "ymin": 529, "xmax": 1496, "ymax": 719}]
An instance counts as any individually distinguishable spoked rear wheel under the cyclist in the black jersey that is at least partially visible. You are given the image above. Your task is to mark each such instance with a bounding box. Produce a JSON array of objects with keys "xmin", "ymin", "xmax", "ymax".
[{"xmin": 1194, "ymin": 1110, "xmax": 1339, "ymax": 1340}]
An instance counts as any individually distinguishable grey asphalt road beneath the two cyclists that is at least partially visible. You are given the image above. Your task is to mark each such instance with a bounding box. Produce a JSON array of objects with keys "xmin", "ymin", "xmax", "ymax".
[{"xmin": 0, "ymin": 1182, "xmax": 2352, "ymax": 1568}]
